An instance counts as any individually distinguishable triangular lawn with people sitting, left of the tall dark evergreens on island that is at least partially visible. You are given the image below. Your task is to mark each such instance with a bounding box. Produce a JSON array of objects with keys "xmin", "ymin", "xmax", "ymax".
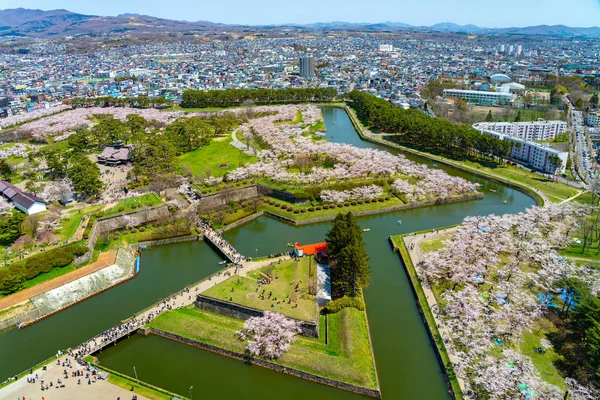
[{"xmin": 203, "ymin": 257, "xmax": 316, "ymax": 321}]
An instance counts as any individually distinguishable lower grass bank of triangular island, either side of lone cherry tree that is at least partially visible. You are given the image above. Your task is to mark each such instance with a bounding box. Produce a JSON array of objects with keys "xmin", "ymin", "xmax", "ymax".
[{"xmin": 150, "ymin": 308, "xmax": 377, "ymax": 389}]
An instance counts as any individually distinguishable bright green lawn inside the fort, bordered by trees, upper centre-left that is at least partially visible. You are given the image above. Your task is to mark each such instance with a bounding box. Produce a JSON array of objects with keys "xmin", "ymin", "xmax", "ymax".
[{"xmin": 177, "ymin": 138, "xmax": 258, "ymax": 176}]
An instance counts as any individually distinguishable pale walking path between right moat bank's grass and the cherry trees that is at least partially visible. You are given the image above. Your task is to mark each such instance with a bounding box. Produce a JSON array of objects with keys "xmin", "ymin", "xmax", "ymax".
[{"xmin": 403, "ymin": 228, "xmax": 470, "ymax": 398}]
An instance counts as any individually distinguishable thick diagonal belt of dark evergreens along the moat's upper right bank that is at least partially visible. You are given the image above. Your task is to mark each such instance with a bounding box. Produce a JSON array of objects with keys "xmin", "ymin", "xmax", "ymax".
[{"xmin": 349, "ymin": 91, "xmax": 511, "ymax": 159}]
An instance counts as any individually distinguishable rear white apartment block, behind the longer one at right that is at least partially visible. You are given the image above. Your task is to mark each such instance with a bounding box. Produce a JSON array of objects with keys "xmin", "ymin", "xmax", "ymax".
[{"xmin": 477, "ymin": 121, "xmax": 567, "ymax": 140}]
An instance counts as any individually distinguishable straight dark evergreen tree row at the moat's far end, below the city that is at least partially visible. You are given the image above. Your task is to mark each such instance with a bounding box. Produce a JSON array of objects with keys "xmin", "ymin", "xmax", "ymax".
[{"xmin": 181, "ymin": 88, "xmax": 337, "ymax": 108}]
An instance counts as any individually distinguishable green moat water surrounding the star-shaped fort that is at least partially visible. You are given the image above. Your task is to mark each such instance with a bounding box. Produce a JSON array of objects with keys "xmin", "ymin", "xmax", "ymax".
[{"xmin": 0, "ymin": 107, "xmax": 535, "ymax": 400}]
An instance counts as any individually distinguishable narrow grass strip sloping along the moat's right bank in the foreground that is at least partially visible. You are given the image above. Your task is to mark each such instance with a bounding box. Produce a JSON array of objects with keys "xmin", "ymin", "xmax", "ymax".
[{"xmin": 390, "ymin": 235, "xmax": 463, "ymax": 400}]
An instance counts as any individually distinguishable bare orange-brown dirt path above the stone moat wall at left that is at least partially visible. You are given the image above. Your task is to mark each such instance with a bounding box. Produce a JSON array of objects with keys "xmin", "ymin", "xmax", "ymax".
[{"xmin": 0, "ymin": 250, "xmax": 117, "ymax": 311}]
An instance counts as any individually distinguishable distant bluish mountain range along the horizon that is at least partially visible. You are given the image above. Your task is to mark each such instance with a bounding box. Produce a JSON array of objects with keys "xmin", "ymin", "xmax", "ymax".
[{"xmin": 0, "ymin": 8, "xmax": 600, "ymax": 37}]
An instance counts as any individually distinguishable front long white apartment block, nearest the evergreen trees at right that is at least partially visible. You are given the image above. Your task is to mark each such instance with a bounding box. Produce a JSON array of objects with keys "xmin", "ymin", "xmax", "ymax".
[{"xmin": 473, "ymin": 124, "xmax": 569, "ymax": 174}]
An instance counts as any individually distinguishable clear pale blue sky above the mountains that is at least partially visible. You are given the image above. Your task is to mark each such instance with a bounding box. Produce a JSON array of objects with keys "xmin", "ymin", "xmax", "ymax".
[{"xmin": 0, "ymin": 0, "xmax": 600, "ymax": 28}]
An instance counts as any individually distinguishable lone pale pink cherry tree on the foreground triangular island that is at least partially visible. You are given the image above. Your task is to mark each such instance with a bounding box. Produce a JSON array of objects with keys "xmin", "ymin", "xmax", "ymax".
[{"xmin": 237, "ymin": 311, "xmax": 300, "ymax": 358}]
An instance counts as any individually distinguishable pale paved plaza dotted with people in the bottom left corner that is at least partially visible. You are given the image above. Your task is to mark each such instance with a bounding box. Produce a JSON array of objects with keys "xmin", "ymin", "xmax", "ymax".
[{"xmin": 0, "ymin": 356, "xmax": 147, "ymax": 400}]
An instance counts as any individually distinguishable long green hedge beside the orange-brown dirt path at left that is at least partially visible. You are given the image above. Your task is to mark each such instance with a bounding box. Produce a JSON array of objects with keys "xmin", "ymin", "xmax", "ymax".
[{"xmin": 0, "ymin": 244, "xmax": 88, "ymax": 293}]
